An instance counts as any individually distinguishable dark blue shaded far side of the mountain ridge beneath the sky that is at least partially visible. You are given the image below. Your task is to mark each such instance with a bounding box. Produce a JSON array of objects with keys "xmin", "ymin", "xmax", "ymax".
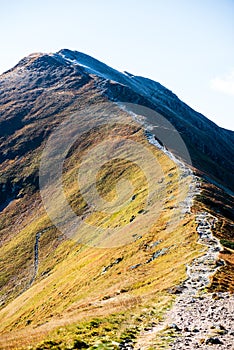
[{"xmin": 0, "ymin": 49, "xmax": 234, "ymax": 193}]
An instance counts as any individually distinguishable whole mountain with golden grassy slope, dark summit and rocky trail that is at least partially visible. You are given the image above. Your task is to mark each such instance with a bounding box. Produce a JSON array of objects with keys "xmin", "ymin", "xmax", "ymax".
[{"xmin": 0, "ymin": 49, "xmax": 234, "ymax": 349}]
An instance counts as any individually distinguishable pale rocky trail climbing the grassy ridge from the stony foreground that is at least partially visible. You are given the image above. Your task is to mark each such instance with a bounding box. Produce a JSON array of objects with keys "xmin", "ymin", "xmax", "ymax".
[{"xmin": 132, "ymin": 135, "xmax": 234, "ymax": 350}]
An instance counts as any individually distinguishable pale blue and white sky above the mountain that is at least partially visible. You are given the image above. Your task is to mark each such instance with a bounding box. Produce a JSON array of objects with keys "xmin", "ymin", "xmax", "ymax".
[{"xmin": 0, "ymin": 0, "xmax": 234, "ymax": 130}]
